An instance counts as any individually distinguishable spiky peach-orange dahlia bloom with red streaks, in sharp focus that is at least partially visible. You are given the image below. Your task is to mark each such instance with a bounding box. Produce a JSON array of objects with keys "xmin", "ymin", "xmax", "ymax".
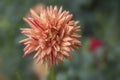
[{"xmin": 20, "ymin": 6, "xmax": 81, "ymax": 65}]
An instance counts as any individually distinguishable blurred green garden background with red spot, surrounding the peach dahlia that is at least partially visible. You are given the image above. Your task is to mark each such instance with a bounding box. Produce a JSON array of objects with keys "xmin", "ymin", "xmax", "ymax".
[{"xmin": 0, "ymin": 0, "xmax": 120, "ymax": 80}]
